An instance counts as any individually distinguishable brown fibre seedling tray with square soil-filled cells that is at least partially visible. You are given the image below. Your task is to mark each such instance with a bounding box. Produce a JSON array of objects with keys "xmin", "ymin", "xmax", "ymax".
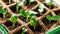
[{"xmin": 0, "ymin": 0, "xmax": 60, "ymax": 34}]
